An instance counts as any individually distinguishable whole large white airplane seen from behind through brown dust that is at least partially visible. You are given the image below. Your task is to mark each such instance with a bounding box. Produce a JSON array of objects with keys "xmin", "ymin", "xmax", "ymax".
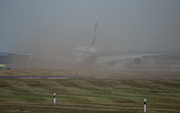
[{"xmin": 2, "ymin": 19, "xmax": 169, "ymax": 67}]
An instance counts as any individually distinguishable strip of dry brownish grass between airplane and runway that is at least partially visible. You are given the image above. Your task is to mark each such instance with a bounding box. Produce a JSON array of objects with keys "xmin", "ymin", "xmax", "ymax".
[{"xmin": 0, "ymin": 69, "xmax": 180, "ymax": 78}]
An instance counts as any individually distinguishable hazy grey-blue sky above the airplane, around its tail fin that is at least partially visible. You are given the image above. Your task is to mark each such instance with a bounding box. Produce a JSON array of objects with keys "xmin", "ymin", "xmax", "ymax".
[{"xmin": 0, "ymin": 0, "xmax": 180, "ymax": 53}]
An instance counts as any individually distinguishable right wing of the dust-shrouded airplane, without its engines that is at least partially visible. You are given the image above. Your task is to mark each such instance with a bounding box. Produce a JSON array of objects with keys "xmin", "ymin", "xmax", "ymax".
[{"xmin": 95, "ymin": 53, "xmax": 171, "ymax": 65}]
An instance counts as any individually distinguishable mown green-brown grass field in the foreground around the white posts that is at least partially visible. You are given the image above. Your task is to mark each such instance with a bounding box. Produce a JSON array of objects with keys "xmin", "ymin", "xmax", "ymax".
[{"xmin": 0, "ymin": 79, "xmax": 180, "ymax": 113}]
